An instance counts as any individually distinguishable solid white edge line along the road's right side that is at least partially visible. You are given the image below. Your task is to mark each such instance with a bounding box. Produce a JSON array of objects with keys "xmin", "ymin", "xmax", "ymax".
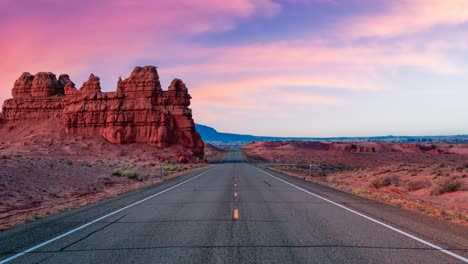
[{"xmin": 254, "ymin": 166, "xmax": 468, "ymax": 263}]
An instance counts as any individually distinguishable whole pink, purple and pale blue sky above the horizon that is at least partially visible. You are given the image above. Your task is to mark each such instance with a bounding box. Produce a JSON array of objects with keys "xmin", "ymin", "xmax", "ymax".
[{"xmin": 0, "ymin": 0, "xmax": 468, "ymax": 137}]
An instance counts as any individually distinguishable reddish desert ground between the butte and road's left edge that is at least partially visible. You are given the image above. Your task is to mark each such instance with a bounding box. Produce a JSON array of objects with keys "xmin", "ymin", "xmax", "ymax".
[{"xmin": 0, "ymin": 119, "xmax": 220, "ymax": 229}]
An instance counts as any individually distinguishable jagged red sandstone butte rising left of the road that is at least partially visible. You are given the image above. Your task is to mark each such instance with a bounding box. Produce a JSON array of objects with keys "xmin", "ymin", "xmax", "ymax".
[{"xmin": 0, "ymin": 66, "xmax": 204, "ymax": 157}]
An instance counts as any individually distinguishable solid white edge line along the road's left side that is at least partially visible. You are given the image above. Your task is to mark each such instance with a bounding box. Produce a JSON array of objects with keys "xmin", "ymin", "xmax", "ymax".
[{"xmin": 0, "ymin": 166, "xmax": 218, "ymax": 264}]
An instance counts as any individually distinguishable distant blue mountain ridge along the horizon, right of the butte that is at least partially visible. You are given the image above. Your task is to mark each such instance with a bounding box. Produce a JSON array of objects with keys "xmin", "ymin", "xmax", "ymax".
[{"xmin": 195, "ymin": 124, "xmax": 468, "ymax": 146}]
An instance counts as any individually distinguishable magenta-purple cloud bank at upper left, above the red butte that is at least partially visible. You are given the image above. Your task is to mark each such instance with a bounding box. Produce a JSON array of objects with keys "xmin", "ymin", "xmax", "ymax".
[{"xmin": 0, "ymin": 0, "xmax": 281, "ymax": 106}]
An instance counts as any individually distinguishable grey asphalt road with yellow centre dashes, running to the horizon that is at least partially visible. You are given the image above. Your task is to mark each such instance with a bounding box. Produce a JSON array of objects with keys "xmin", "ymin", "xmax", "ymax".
[{"xmin": 0, "ymin": 150, "xmax": 468, "ymax": 264}]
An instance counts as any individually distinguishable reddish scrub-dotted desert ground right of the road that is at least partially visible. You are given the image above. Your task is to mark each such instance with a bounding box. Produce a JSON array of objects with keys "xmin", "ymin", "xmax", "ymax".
[{"xmin": 242, "ymin": 142, "xmax": 468, "ymax": 225}]
